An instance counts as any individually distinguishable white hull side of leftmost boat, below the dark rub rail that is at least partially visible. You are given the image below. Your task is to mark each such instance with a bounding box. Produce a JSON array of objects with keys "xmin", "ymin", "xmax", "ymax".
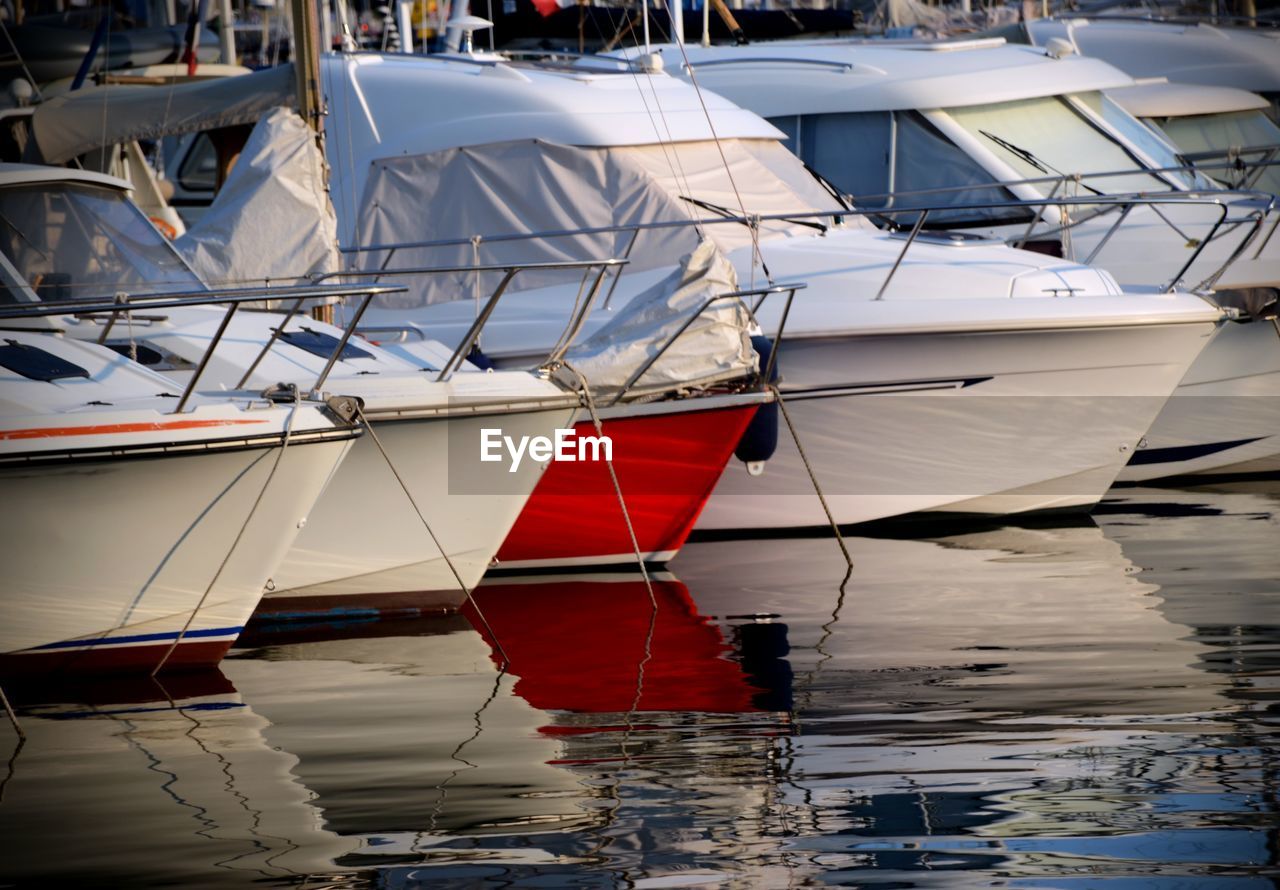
[{"xmin": 0, "ymin": 437, "xmax": 351, "ymax": 668}]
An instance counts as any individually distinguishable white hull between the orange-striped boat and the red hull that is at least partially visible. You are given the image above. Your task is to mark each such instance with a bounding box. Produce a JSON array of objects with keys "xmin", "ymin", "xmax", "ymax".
[{"xmin": 261, "ymin": 406, "xmax": 575, "ymax": 615}]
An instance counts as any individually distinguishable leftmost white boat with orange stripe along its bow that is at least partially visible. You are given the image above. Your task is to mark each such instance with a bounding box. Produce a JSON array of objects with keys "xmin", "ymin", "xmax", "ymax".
[{"xmin": 0, "ymin": 321, "xmax": 357, "ymax": 675}]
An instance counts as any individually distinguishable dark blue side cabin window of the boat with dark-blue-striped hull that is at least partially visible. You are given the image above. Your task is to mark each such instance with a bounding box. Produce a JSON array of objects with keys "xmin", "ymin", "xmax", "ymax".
[{"xmin": 771, "ymin": 111, "xmax": 1030, "ymax": 228}]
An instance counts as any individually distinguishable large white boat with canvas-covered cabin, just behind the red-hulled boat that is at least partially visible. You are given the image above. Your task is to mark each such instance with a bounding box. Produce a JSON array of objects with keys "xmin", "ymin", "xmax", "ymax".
[{"xmin": 324, "ymin": 55, "xmax": 1221, "ymax": 529}]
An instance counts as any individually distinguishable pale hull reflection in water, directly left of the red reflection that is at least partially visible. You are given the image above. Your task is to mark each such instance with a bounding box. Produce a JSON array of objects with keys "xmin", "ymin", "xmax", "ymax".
[{"xmin": 227, "ymin": 615, "xmax": 594, "ymax": 867}]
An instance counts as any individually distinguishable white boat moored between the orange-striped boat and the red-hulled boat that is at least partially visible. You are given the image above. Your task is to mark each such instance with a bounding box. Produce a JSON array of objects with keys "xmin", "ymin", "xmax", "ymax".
[{"xmin": 0, "ymin": 166, "xmax": 579, "ymax": 624}]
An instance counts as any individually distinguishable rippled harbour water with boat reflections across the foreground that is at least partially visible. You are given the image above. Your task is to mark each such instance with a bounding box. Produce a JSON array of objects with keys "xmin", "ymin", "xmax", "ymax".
[{"xmin": 0, "ymin": 483, "xmax": 1280, "ymax": 890}]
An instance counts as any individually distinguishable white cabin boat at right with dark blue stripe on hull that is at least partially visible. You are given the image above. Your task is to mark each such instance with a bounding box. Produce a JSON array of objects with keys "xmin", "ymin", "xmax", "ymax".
[{"xmin": 640, "ymin": 40, "xmax": 1280, "ymax": 480}]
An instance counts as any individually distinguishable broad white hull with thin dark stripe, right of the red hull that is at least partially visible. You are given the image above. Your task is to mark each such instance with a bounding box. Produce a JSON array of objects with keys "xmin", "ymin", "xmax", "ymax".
[{"xmin": 698, "ymin": 321, "xmax": 1213, "ymax": 530}]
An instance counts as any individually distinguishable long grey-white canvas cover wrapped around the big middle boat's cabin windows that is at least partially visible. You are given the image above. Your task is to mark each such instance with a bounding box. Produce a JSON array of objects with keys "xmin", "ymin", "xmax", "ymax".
[{"xmin": 355, "ymin": 140, "xmax": 840, "ymax": 309}]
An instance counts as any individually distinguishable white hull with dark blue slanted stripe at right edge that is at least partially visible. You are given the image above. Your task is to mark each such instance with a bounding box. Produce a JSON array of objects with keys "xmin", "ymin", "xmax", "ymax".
[{"xmin": 1120, "ymin": 320, "xmax": 1280, "ymax": 481}]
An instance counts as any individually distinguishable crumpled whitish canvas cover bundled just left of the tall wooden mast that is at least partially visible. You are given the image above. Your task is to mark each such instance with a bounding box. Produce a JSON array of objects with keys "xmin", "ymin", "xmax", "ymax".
[{"xmin": 174, "ymin": 108, "xmax": 339, "ymax": 284}]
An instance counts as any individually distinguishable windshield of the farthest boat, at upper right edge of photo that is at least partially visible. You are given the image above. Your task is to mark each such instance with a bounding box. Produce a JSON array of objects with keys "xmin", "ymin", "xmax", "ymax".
[{"xmin": 1160, "ymin": 110, "xmax": 1280, "ymax": 195}]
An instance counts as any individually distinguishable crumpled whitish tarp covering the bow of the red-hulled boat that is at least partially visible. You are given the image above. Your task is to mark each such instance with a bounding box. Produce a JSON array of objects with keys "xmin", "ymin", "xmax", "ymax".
[{"xmin": 556, "ymin": 238, "xmax": 759, "ymax": 394}]
